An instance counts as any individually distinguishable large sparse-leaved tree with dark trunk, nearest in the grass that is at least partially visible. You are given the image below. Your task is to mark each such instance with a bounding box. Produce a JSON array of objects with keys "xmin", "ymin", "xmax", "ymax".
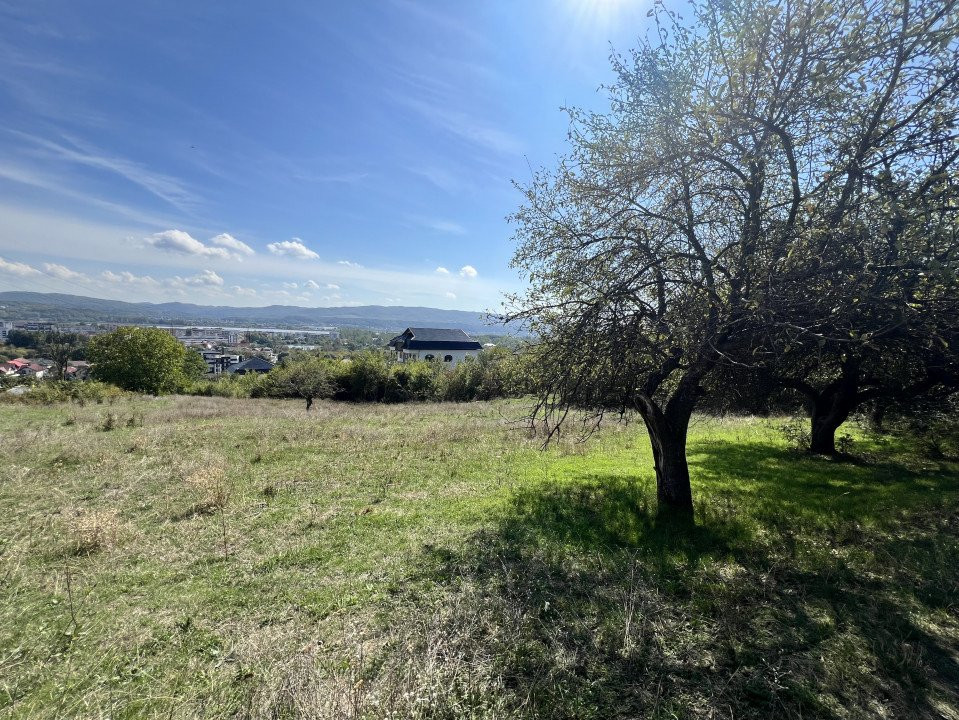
[{"xmin": 507, "ymin": 0, "xmax": 956, "ymax": 514}]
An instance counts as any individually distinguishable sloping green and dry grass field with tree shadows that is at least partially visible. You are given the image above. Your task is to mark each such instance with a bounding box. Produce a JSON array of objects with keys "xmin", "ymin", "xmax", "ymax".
[{"xmin": 0, "ymin": 397, "xmax": 959, "ymax": 720}]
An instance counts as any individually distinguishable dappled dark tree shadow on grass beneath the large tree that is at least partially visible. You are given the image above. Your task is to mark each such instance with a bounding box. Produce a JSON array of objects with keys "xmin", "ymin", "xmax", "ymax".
[{"xmin": 404, "ymin": 462, "xmax": 959, "ymax": 720}]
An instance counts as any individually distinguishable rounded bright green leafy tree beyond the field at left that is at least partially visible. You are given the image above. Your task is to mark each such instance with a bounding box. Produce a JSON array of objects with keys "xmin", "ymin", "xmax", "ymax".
[{"xmin": 87, "ymin": 327, "xmax": 186, "ymax": 395}]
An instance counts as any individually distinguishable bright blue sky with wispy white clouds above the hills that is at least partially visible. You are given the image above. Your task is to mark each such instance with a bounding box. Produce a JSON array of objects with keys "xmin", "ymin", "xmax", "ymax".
[{"xmin": 0, "ymin": 0, "xmax": 648, "ymax": 310}]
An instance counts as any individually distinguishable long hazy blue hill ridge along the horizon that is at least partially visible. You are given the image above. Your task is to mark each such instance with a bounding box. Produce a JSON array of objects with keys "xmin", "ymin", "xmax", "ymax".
[{"xmin": 0, "ymin": 291, "xmax": 517, "ymax": 335}]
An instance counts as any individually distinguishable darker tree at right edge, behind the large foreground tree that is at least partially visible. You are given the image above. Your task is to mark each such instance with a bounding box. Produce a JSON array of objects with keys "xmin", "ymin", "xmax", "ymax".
[{"xmin": 760, "ymin": 18, "xmax": 959, "ymax": 454}]
